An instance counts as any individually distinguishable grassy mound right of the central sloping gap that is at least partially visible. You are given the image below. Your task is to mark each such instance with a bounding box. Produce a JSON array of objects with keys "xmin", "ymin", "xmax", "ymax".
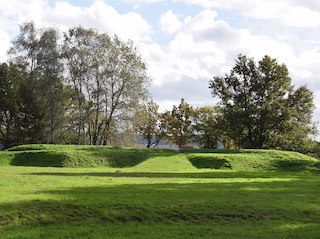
[{"xmin": 184, "ymin": 149, "xmax": 319, "ymax": 171}]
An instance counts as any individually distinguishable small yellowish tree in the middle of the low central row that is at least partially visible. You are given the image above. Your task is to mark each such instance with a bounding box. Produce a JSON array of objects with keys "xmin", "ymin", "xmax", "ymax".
[{"xmin": 162, "ymin": 99, "xmax": 193, "ymax": 147}]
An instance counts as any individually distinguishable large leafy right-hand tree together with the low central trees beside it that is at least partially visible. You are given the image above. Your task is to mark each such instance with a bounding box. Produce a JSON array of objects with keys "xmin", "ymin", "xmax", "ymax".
[{"xmin": 140, "ymin": 55, "xmax": 320, "ymax": 157}]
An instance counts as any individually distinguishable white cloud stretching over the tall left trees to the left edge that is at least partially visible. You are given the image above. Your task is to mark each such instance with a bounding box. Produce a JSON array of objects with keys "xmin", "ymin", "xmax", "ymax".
[{"xmin": 0, "ymin": 0, "xmax": 152, "ymax": 60}]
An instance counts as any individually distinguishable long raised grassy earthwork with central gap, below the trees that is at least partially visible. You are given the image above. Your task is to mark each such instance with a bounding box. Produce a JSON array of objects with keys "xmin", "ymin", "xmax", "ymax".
[{"xmin": 0, "ymin": 144, "xmax": 319, "ymax": 172}]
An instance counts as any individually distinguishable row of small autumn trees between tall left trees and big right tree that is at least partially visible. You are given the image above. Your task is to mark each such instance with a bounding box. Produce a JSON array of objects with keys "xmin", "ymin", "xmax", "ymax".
[{"xmin": 137, "ymin": 99, "xmax": 222, "ymax": 148}]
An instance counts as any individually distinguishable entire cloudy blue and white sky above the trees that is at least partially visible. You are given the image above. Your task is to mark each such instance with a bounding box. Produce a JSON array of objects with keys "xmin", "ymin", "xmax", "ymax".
[{"xmin": 0, "ymin": 0, "xmax": 320, "ymax": 130}]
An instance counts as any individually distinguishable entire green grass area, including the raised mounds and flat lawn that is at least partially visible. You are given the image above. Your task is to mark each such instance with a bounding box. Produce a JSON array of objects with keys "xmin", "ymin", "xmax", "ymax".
[{"xmin": 0, "ymin": 145, "xmax": 320, "ymax": 239}]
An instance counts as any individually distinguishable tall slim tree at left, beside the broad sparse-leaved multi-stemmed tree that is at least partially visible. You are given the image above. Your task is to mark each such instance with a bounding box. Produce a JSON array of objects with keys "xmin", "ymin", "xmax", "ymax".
[{"xmin": 9, "ymin": 22, "xmax": 64, "ymax": 143}]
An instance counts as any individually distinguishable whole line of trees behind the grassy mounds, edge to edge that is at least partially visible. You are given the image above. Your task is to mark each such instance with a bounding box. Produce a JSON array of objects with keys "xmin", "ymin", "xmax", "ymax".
[{"xmin": 0, "ymin": 22, "xmax": 318, "ymax": 157}]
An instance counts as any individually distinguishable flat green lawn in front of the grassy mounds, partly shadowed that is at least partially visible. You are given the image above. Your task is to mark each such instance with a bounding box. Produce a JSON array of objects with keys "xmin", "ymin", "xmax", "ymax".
[{"xmin": 0, "ymin": 166, "xmax": 320, "ymax": 239}]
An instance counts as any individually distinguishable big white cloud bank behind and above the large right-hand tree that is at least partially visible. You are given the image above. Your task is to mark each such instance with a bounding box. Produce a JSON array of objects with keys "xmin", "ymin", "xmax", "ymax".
[{"xmin": 142, "ymin": 6, "xmax": 320, "ymax": 113}]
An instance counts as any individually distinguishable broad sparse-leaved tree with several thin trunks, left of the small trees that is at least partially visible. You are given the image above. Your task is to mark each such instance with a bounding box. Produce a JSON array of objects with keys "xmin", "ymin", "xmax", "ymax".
[{"xmin": 64, "ymin": 27, "xmax": 150, "ymax": 145}]
